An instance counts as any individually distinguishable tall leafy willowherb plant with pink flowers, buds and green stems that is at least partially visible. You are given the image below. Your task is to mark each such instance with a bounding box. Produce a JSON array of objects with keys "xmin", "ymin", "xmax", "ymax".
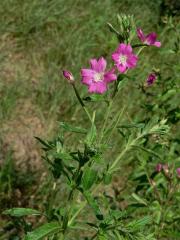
[{"xmin": 4, "ymin": 15, "xmax": 180, "ymax": 240}]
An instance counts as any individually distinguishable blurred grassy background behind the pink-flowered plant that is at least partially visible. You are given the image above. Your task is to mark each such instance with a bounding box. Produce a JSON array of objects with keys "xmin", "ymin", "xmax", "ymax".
[{"xmin": 0, "ymin": 0, "xmax": 180, "ymax": 239}]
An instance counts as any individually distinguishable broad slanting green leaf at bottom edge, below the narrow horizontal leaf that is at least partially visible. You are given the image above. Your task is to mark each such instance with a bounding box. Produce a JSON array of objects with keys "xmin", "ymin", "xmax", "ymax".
[{"xmin": 25, "ymin": 222, "xmax": 62, "ymax": 240}]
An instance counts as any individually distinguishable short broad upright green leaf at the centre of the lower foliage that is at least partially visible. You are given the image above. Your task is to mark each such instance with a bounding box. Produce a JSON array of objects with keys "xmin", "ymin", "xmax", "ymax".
[{"xmin": 82, "ymin": 167, "xmax": 97, "ymax": 191}]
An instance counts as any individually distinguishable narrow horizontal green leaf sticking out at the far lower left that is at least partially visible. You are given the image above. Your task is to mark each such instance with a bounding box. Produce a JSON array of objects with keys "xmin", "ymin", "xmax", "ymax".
[{"xmin": 3, "ymin": 208, "xmax": 42, "ymax": 217}]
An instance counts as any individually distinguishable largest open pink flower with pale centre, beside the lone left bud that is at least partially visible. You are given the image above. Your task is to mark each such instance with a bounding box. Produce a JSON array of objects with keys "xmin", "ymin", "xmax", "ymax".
[{"xmin": 81, "ymin": 57, "xmax": 117, "ymax": 94}]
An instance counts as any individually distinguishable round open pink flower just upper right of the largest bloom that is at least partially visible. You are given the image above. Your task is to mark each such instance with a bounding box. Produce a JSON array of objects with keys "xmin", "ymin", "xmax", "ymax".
[{"xmin": 112, "ymin": 43, "xmax": 138, "ymax": 73}]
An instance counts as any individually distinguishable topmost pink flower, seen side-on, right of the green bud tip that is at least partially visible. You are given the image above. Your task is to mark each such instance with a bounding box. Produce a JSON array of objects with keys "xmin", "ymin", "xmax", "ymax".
[{"xmin": 137, "ymin": 28, "xmax": 161, "ymax": 47}]
